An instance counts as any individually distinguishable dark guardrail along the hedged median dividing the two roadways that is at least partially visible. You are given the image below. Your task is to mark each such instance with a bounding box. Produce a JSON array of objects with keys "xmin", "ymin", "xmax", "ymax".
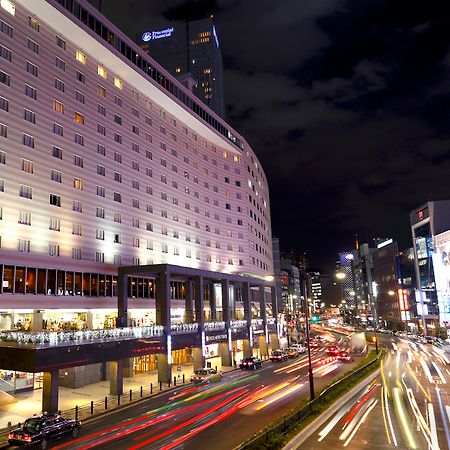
[{"xmin": 238, "ymin": 352, "xmax": 382, "ymax": 450}]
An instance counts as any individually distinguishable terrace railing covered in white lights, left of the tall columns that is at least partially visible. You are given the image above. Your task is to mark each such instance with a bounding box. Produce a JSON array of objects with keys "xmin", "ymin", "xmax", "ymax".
[{"xmin": 0, "ymin": 325, "xmax": 164, "ymax": 347}]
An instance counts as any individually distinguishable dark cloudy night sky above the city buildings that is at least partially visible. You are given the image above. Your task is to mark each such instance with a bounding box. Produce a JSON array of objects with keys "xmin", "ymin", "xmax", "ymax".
[{"xmin": 94, "ymin": 0, "xmax": 450, "ymax": 269}]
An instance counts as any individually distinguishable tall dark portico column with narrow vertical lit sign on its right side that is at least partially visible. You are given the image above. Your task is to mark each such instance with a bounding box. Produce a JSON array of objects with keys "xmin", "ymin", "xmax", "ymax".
[{"xmin": 155, "ymin": 271, "xmax": 172, "ymax": 383}]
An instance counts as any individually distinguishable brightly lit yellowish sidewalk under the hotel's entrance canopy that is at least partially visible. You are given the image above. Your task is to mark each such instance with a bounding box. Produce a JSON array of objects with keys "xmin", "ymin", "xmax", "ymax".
[{"xmin": 0, "ymin": 364, "xmax": 234, "ymax": 428}]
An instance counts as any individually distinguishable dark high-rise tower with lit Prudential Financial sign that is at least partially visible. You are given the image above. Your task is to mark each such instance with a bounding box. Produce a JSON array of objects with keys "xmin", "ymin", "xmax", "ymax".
[{"xmin": 137, "ymin": 17, "xmax": 225, "ymax": 118}]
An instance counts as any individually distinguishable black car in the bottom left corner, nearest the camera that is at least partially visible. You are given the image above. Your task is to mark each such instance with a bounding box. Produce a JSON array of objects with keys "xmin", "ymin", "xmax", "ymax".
[{"xmin": 8, "ymin": 414, "xmax": 81, "ymax": 450}]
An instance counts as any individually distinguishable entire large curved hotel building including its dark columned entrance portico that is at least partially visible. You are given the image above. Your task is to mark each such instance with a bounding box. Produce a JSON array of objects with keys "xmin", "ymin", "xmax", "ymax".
[{"xmin": 0, "ymin": 0, "xmax": 277, "ymax": 411}]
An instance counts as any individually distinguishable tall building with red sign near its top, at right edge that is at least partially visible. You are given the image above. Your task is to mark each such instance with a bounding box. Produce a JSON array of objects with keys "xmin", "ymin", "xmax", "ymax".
[{"xmin": 409, "ymin": 200, "xmax": 450, "ymax": 334}]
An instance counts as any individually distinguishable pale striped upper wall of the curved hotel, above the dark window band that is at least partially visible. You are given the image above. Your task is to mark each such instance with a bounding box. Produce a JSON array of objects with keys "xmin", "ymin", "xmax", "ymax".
[{"xmin": 0, "ymin": 0, "xmax": 273, "ymax": 312}]
